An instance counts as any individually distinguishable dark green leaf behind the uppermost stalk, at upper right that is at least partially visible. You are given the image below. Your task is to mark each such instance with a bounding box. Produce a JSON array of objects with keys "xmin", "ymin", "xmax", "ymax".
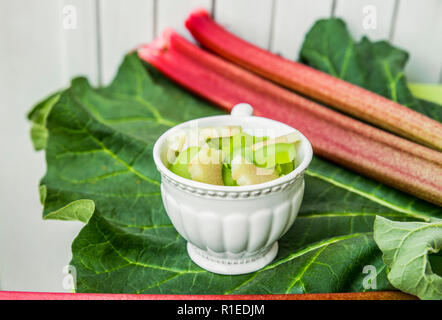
[{"xmin": 300, "ymin": 19, "xmax": 442, "ymax": 121}]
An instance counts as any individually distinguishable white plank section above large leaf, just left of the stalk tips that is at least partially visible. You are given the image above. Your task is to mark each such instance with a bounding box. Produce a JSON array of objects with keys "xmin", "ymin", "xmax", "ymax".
[{"xmin": 99, "ymin": 0, "xmax": 154, "ymax": 84}]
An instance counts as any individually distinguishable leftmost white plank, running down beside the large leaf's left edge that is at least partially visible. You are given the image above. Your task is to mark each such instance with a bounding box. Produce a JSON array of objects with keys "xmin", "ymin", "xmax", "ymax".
[{"xmin": 0, "ymin": 0, "xmax": 81, "ymax": 291}]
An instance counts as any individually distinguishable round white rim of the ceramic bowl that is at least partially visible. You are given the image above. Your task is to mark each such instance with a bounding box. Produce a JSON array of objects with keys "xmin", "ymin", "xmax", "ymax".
[{"xmin": 153, "ymin": 114, "xmax": 313, "ymax": 194}]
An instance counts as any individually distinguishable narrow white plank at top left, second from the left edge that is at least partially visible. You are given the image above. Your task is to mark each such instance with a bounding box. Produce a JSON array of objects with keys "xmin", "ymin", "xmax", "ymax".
[{"xmin": 61, "ymin": 0, "xmax": 98, "ymax": 85}]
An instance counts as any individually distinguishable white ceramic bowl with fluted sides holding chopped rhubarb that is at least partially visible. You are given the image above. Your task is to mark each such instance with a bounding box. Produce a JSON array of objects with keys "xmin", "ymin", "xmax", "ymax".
[{"xmin": 153, "ymin": 104, "xmax": 313, "ymax": 274}]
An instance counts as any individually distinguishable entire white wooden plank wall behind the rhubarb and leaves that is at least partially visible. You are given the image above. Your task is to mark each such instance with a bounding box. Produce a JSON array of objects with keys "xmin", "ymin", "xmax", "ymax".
[{"xmin": 0, "ymin": 0, "xmax": 442, "ymax": 291}]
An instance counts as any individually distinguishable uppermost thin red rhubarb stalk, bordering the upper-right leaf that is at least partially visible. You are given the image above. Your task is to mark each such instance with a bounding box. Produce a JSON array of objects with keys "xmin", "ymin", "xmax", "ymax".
[{"xmin": 186, "ymin": 9, "xmax": 442, "ymax": 150}]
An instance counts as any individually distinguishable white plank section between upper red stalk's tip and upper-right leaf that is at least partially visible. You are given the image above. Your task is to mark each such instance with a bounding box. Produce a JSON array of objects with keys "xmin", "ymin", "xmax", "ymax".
[{"xmin": 270, "ymin": 0, "xmax": 332, "ymax": 60}]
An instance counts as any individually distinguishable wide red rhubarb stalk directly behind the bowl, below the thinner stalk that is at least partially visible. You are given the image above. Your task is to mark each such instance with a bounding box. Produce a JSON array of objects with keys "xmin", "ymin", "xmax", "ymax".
[{"xmin": 138, "ymin": 29, "xmax": 442, "ymax": 205}]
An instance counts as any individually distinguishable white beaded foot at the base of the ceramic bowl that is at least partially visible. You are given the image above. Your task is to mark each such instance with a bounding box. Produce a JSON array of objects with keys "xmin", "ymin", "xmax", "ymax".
[{"xmin": 187, "ymin": 242, "xmax": 278, "ymax": 275}]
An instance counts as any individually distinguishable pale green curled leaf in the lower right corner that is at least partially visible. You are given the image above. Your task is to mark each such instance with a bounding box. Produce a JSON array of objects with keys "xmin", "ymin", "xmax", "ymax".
[{"xmin": 374, "ymin": 217, "xmax": 442, "ymax": 300}]
